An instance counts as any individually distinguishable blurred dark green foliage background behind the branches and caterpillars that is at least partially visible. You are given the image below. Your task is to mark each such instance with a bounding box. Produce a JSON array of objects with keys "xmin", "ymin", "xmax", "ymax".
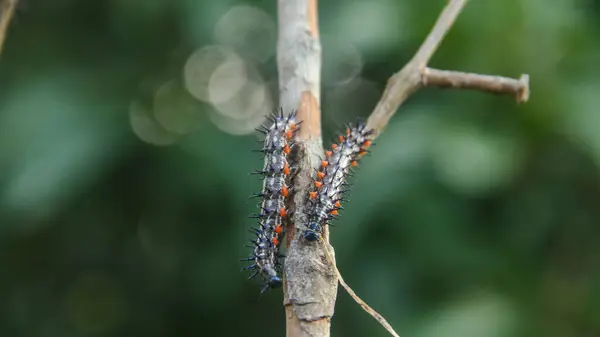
[{"xmin": 0, "ymin": 0, "xmax": 600, "ymax": 337}]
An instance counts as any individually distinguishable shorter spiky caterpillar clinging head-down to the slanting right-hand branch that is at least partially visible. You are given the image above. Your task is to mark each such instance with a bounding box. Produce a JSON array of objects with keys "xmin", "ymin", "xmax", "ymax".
[{"xmin": 304, "ymin": 121, "xmax": 373, "ymax": 241}]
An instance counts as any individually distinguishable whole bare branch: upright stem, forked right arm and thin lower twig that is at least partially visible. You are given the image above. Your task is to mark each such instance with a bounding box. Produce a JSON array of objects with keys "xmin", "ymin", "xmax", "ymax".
[{"xmin": 277, "ymin": 0, "xmax": 529, "ymax": 337}]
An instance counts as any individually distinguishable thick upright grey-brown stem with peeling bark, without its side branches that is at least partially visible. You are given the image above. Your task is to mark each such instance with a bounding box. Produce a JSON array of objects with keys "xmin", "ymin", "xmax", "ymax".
[{"xmin": 277, "ymin": 0, "xmax": 337, "ymax": 337}]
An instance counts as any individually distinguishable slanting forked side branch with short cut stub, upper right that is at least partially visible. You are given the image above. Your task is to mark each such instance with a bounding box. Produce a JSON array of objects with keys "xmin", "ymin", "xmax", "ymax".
[{"xmin": 367, "ymin": 0, "xmax": 529, "ymax": 137}]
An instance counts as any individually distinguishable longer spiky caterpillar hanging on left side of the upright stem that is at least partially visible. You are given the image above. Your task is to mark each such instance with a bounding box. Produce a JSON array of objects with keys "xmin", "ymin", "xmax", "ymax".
[{"xmin": 243, "ymin": 109, "xmax": 299, "ymax": 294}]
